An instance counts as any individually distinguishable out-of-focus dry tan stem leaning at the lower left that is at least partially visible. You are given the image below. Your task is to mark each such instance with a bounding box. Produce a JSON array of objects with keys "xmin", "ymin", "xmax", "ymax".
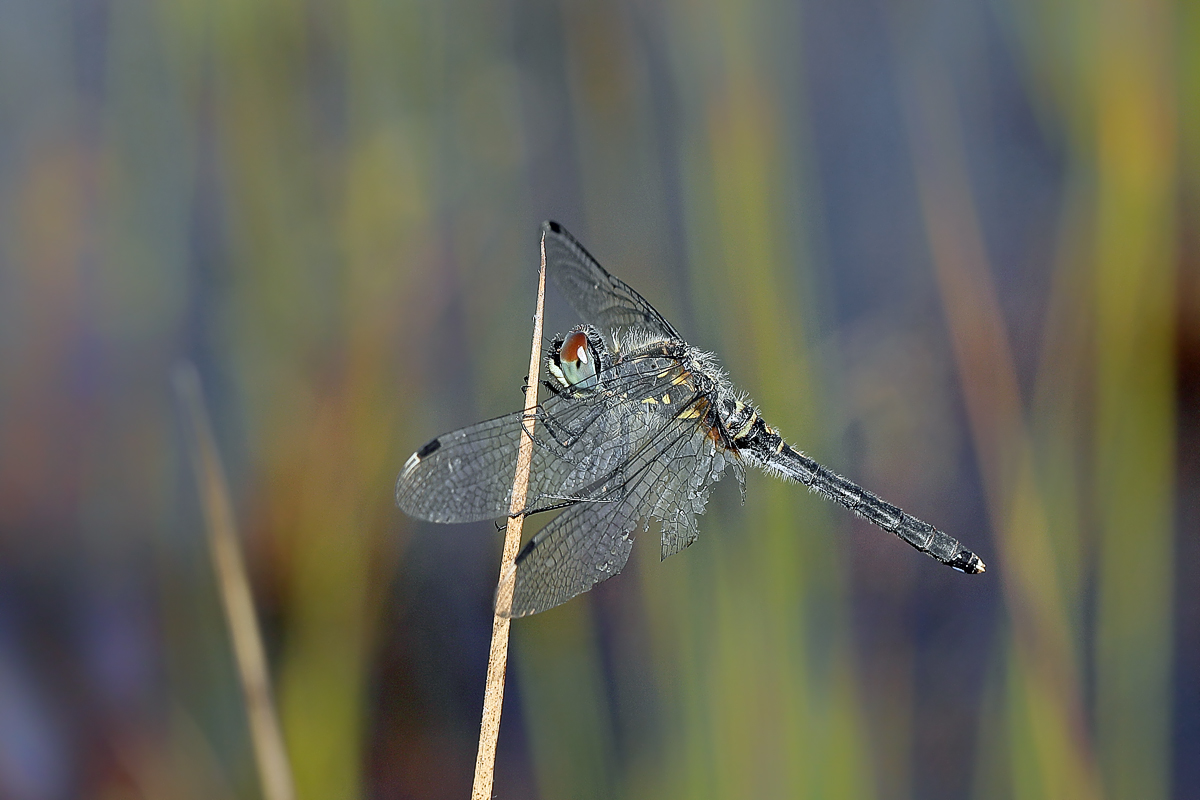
[{"xmin": 174, "ymin": 362, "xmax": 295, "ymax": 800}]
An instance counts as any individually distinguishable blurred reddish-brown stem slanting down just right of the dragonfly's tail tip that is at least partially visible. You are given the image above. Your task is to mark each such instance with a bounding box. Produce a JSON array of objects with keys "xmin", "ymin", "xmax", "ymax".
[{"xmin": 905, "ymin": 64, "xmax": 1102, "ymax": 799}]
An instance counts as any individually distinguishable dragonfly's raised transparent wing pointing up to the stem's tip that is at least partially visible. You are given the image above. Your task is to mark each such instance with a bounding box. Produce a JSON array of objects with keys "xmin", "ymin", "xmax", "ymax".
[{"xmin": 541, "ymin": 222, "xmax": 682, "ymax": 339}]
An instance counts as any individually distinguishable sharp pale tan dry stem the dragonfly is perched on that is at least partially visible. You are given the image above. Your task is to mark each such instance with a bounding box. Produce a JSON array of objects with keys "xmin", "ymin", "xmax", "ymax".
[{"xmin": 470, "ymin": 227, "xmax": 546, "ymax": 800}]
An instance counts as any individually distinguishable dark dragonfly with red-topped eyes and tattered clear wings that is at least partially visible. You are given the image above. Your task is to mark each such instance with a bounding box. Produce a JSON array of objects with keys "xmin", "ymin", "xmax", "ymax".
[{"xmin": 396, "ymin": 222, "xmax": 984, "ymax": 616}]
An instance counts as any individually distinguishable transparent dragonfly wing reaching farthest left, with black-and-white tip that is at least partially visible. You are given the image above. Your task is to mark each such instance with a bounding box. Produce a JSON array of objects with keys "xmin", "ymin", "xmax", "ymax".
[{"xmin": 396, "ymin": 355, "xmax": 691, "ymax": 522}]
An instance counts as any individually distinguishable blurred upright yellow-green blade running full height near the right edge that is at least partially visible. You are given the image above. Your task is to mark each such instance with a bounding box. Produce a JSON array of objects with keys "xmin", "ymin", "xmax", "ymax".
[{"xmin": 1084, "ymin": 2, "xmax": 1176, "ymax": 800}]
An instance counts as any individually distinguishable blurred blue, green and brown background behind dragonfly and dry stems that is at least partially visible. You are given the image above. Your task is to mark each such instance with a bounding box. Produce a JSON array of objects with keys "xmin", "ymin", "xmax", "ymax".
[{"xmin": 0, "ymin": 0, "xmax": 1200, "ymax": 800}]
